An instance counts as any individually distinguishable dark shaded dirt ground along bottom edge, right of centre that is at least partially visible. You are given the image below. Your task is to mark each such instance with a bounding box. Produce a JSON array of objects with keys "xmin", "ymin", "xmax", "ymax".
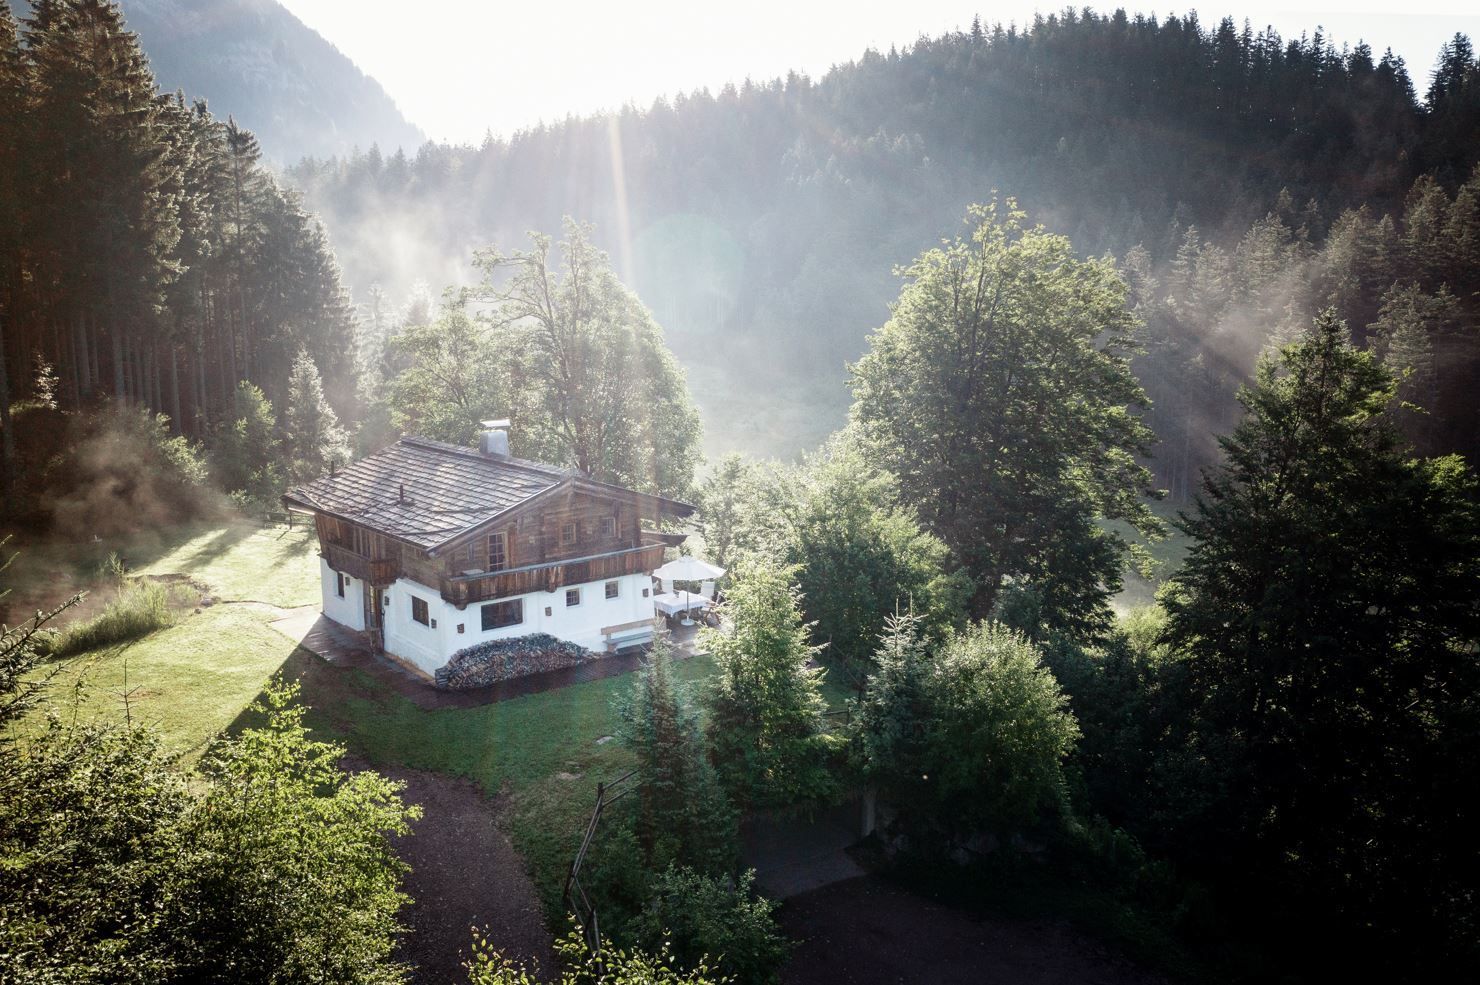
[{"xmin": 780, "ymin": 876, "xmax": 1165, "ymax": 985}]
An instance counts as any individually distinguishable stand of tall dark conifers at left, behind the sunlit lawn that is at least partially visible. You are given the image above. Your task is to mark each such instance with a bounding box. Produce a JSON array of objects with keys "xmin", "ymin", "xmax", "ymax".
[{"xmin": 0, "ymin": 0, "xmax": 357, "ymax": 515}]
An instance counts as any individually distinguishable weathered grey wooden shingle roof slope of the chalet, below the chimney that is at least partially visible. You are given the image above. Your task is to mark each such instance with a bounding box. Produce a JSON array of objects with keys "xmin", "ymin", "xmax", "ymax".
[{"xmin": 283, "ymin": 438, "xmax": 580, "ymax": 550}]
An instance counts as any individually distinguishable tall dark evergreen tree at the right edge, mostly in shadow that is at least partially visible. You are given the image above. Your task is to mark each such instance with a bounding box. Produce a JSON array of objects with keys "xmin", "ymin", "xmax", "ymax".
[{"xmin": 1165, "ymin": 312, "xmax": 1480, "ymax": 970}]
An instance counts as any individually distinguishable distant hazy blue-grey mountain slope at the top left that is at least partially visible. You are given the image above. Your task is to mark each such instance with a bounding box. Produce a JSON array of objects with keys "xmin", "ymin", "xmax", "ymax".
[{"xmin": 13, "ymin": 0, "xmax": 425, "ymax": 164}]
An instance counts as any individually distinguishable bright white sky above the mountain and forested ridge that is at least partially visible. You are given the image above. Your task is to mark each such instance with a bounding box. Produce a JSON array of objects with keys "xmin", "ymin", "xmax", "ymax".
[{"xmin": 281, "ymin": 0, "xmax": 1480, "ymax": 143}]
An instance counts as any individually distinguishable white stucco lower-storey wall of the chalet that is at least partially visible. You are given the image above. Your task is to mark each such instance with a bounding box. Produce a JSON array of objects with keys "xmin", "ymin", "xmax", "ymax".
[{"xmin": 378, "ymin": 574, "xmax": 654, "ymax": 673}]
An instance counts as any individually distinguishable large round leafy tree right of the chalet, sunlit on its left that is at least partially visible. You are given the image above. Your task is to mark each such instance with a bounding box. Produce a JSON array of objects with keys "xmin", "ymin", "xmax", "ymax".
[{"xmin": 851, "ymin": 200, "xmax": 1159, "ymax": 634}]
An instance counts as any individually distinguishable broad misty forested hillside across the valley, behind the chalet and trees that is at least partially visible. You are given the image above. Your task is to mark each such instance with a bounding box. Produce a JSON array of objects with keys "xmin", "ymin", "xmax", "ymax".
[{"xmin": 289, "ymin": 12, "xmax": 1480, "ymax": 473}]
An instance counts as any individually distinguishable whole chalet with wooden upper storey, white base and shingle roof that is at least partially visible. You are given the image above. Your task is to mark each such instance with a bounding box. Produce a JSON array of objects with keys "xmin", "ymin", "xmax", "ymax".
[{"xmin": 283, "ymin": 422, "xmax": 694, "ymax": 674}]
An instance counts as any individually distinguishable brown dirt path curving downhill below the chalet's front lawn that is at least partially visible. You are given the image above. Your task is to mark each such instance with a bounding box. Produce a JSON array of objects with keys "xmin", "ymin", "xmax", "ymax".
[{"xmin": 345, "ymin": 757, "xmax": 555, "ymax": 985}]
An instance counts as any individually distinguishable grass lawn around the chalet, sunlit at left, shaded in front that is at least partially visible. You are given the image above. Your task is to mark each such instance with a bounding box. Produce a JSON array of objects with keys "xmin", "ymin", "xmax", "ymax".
[{"xmin": 23, "ymin": 525, "xmax": 713, "ymax": 913}]
